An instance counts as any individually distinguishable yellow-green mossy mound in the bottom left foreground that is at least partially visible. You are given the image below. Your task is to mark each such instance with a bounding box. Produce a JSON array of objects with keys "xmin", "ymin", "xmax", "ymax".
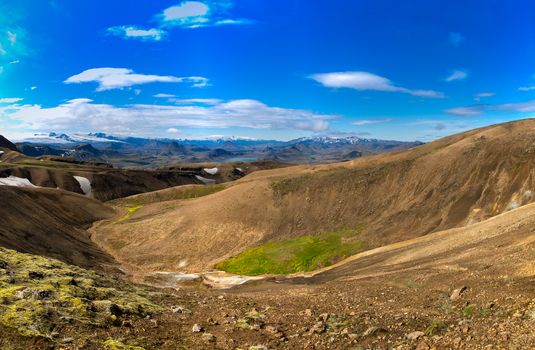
[{"xmin": 0, "ymin": 248, "xmax": 162, "ymax": 339}]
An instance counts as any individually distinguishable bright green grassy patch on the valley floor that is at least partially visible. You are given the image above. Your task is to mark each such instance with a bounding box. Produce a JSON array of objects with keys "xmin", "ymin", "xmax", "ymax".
[{"xmin": 216, "ymin": 226, "xmax": 363, "ymax": 276}]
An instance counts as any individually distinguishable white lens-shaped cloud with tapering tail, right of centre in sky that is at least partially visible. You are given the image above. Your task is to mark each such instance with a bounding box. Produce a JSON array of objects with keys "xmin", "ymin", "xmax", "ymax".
[{"xmin": 310, "ymin": 71, "xmax": 445, "ymax": 98}]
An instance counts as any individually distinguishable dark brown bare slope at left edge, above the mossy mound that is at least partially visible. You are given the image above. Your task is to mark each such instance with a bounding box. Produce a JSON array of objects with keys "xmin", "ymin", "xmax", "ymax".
[{"xmin": 0, "ymin": 186, "xmax": 114, "ymax": 268}]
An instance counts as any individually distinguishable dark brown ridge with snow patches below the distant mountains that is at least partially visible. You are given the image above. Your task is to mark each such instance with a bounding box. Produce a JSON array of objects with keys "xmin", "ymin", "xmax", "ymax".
[{"xmin": 0, "ymin": 144, "xmax": 287, "ymax": 201}]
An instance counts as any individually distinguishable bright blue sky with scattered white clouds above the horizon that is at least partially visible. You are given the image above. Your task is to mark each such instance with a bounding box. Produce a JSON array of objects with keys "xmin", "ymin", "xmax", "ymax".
[{"xmin": 0, "ymin": 0, "xmax": 535, "ymax": 141}]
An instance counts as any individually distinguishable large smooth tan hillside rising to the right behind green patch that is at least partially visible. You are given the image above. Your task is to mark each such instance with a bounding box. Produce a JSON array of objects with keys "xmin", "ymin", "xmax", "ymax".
[{"xmin": 93, "ymin": 120, "xmax": 535, "ymax": 273}]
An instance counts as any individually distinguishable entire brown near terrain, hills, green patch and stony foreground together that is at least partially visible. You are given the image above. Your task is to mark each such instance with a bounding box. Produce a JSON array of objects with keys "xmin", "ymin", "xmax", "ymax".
[{"xmin": 0, "ymin": 120, "xmax": 535, "ymax": 350}]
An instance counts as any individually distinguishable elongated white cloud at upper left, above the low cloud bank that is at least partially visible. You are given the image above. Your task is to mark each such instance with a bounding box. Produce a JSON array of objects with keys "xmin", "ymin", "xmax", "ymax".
[{"xmin": 64, "ymin": 68, "xmax": 208, "ymax": 91}]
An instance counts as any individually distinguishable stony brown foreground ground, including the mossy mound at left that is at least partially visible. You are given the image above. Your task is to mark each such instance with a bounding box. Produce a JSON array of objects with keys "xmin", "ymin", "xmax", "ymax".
[{"xmin": 0, "ymin": 242, "xmax": 535, "ymax": 349}]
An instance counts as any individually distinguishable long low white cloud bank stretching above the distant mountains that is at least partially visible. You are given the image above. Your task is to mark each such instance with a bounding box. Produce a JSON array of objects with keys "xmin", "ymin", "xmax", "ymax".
[{"xmin": 0, "ymin": 99, "xmax": 336, "ymax": 135}]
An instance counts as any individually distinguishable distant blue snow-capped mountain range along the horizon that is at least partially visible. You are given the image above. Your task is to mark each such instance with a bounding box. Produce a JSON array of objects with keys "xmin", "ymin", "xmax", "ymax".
[{"xmin": 12, "ymin": 132, "xmax": 422, "ymax": 167}]
